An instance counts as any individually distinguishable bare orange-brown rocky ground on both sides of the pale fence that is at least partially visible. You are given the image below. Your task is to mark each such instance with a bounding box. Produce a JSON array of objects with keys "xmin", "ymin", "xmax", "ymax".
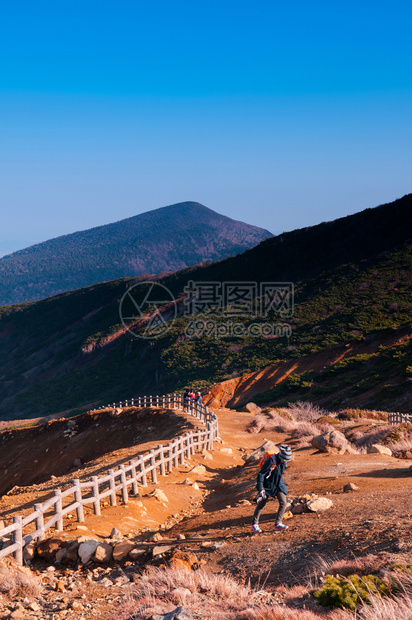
[{"xmin": 0, "ymin": 409, "xmax": 412, "ymax": 620}]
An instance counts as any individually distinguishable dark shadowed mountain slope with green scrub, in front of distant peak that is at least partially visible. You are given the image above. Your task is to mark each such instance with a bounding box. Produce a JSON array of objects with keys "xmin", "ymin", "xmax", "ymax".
[{"xmin": 0, "ymin": 191, "xmax": 412, "ymax": 419}]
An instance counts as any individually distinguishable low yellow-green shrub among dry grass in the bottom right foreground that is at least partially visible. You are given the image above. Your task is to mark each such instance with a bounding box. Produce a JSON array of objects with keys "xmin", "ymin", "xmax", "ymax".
[{"xmin": 311, "ymin": 575, "xmax": 390, "ymax": 610}]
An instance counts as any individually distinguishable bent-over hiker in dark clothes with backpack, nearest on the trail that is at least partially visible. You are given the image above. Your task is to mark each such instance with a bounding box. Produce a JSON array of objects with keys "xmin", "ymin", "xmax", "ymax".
[{"xmin": 252, "ymin": 444, "xmax": 292, "ymax": 534}]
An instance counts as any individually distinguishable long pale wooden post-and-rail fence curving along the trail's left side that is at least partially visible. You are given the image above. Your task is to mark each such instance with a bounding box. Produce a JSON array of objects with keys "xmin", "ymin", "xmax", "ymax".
[{"xmin": 0, "ymin": 394, "xmax": 219, "ymax": 564}]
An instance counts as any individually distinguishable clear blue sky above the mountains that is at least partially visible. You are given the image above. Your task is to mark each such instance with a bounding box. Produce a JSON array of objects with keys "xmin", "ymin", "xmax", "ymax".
[{"xmin": 0, "ymin": 0, "xmax": 412, "ymax": 255}]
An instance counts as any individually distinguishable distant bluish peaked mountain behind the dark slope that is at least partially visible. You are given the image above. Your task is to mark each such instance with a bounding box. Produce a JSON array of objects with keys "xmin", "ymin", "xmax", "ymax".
[{"xmin": 0, "ymin": 202, "xmax": 272, "ymax": 305}]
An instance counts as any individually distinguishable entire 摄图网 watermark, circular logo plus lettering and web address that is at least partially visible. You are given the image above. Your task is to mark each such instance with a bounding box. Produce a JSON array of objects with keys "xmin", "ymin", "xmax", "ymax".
[{"xmin": 119, "ymin": 280, "xmax": 294, "ymax": 339}]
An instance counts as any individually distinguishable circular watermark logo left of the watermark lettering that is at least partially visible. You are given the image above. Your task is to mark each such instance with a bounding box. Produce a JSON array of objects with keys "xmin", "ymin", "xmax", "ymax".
[{"xmin": 119, "ymin": 280, "xmax": 177, "ymax": 340}]
